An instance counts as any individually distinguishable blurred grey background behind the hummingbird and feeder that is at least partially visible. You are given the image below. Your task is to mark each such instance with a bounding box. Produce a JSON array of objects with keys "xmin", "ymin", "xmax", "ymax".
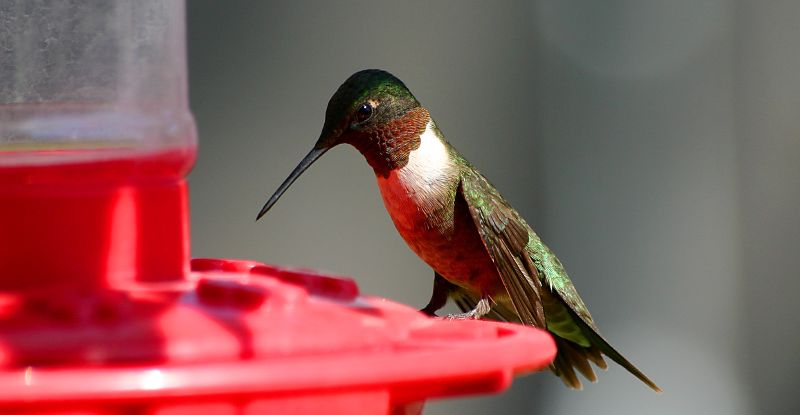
[{"xmin": 188, "ymin": 0, "xmax": 800, "ymax": 415}]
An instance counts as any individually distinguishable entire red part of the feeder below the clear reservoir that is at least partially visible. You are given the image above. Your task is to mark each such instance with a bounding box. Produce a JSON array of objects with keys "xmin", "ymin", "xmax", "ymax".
[{"xmin": 0, "ymin": 152, "xmax": 555, "ymax": 415}]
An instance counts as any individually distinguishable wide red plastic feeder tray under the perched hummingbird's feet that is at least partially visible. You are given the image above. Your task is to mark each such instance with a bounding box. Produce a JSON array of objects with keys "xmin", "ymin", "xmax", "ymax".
[{"xmin": 0, "ymin": 259, "xmax": 556, "ymax": 405}]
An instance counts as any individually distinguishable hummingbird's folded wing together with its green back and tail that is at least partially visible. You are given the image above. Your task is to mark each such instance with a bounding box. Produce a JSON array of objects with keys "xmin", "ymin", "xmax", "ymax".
[{"xmin": 457, "ymin": 168, "xmax": 660, "ymax": 391}]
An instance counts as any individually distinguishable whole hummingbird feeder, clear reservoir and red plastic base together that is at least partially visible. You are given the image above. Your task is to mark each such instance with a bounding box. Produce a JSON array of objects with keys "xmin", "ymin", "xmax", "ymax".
[{"xmin": 0, "ymin": 0, "xmax": 555, "ymax": 415}]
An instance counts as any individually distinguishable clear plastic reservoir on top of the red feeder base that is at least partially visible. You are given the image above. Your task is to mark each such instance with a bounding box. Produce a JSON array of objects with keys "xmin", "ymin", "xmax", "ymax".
[{"xmin": 0, "ymin": 0, "xmax": 196, "ymax": 168}]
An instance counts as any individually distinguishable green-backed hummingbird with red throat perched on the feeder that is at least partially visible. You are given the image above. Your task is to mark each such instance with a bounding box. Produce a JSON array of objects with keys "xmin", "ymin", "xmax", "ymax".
[{"xmin": 257, "ymin": 69, "xmax": 661, "ymax": 392}]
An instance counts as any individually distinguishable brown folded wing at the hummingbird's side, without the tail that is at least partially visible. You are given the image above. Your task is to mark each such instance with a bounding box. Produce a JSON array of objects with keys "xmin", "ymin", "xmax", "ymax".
[{"xmin": 458, "ymin": 168, "xmax": 546, "ymax": 328}]
